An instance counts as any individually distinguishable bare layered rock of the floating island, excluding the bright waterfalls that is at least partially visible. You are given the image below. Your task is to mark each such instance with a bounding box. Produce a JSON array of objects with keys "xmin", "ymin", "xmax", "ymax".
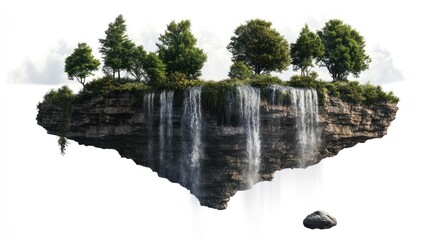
[{"xmin": 37, "ymin": 86, "xmax": 398, "ymax": 209}]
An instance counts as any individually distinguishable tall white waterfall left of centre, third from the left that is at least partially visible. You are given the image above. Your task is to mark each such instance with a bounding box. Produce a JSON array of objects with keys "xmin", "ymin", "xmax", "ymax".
[{"xmin": 182, "ymin": 87, "xmax": 203, "ymax": 194}]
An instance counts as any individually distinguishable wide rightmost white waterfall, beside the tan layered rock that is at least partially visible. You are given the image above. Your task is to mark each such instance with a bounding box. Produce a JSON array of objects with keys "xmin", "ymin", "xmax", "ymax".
[{"xmin": 270, "ymin": 86, "xmax": 320, "ymax": 167}]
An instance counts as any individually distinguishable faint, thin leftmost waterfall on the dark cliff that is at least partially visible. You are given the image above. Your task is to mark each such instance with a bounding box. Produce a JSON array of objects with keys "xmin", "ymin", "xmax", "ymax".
[{"xmin": 143, "ymin": 93, "xmax": 155, "ymax": 166}]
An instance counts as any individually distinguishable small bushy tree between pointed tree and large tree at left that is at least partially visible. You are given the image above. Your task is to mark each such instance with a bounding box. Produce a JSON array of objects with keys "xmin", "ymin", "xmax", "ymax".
[{"xmin": 143, "ymin": 52, "xmax": 166, "ymax": 86}]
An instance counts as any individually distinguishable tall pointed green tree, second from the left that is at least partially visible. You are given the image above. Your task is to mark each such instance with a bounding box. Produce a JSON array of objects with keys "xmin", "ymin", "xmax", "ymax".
[{"xmin": 99, "ymin": 15, "xmax": 135, "ymax": 79}]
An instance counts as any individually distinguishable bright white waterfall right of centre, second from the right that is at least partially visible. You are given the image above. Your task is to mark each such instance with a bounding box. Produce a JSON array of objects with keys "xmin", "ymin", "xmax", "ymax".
[{"xmin": 237, "ymin": 86, "xmax": 261, "ymax": 186}]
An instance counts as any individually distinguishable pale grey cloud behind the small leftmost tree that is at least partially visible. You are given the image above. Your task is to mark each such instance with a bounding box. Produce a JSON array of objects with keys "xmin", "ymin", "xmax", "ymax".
[{"xmin": 7, "ymin": 41, "xmax": 73, "ymax": 84}]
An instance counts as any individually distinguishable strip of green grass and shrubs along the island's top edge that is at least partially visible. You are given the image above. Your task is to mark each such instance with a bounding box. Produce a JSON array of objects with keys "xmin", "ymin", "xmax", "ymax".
[{"xmin": 38, "ymin": 76, "xmax": 399, "ymax": 107}]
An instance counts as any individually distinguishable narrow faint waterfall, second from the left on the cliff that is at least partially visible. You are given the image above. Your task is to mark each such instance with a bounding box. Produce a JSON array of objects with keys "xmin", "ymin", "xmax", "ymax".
[{"xmin": 159, "ymin": 91, "xmax": 174, "ymax": 175}]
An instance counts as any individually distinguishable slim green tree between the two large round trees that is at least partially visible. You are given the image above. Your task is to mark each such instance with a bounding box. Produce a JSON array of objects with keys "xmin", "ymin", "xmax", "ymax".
[{"xmin": 290, "ymin": 24, "xmax": 325, "ymax": 76}]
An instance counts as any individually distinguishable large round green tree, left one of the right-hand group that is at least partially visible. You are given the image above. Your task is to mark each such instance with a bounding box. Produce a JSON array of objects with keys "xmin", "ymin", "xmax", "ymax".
[{"xmin": 227, "ymin": 19, "xmax": 290, "ymax": 75}]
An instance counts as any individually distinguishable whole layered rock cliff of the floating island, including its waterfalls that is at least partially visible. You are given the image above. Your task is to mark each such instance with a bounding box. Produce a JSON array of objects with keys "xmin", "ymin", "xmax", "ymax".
[{"xmin": 37, "ymin": 88, "xmax": 398, "ymax": 209}]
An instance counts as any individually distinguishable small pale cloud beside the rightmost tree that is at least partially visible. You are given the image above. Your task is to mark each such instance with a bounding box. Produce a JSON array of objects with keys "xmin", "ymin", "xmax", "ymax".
[{"xmin": 360, "ymin": 46, "xmax": 405, "ymax": 84}]
